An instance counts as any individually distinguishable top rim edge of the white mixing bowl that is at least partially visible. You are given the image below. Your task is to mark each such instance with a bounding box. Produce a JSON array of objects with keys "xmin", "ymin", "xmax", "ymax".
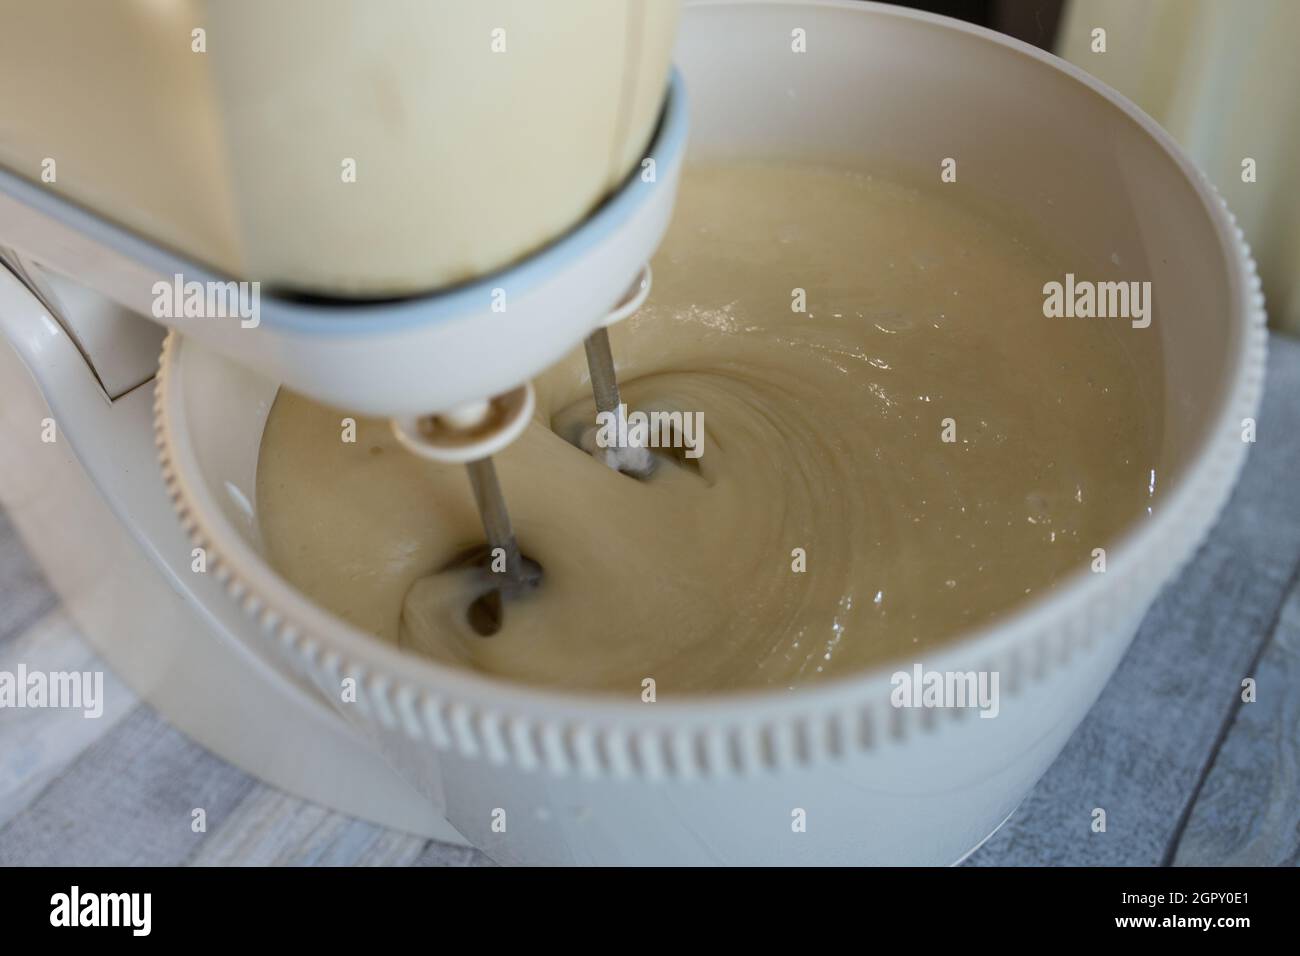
[{"xmin": 155, "ymin": 0, "xmax": 1266, "ymax": 749}]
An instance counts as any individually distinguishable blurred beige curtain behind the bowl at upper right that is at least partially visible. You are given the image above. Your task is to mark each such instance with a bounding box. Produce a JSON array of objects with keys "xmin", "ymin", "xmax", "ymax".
[{"xmin": 1057, "ymin": 0, "xmax": 1300, "ymax": 333}]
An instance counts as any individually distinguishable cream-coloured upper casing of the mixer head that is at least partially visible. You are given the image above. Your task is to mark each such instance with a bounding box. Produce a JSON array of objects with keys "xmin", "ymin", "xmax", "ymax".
[{"xmin": 0, "ymin": 0, "xmax": 679, "ymax": 299}]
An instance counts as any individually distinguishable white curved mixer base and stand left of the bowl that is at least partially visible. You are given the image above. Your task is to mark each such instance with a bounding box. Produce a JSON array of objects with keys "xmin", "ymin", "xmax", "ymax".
[{"xmin": 0, "ymin": 287, "xmax": 467, "ymax": 845}]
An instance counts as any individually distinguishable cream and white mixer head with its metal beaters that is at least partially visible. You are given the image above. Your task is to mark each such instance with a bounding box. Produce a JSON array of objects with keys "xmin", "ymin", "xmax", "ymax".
[{"xmin": 0, "ymin": 0, "xmax": 685, "ymax": 635}]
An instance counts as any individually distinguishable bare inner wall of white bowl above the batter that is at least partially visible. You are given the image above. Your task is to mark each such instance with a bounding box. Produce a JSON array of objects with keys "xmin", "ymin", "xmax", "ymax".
[{"xmin": 177, "ymin": 3, "xmax": 1244, "ymax": 686}]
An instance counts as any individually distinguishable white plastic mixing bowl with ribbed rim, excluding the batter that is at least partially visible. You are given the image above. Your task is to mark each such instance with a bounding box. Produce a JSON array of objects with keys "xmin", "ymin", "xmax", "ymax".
[{"xmin": 157, "ymin": 3, "xmax": 1265, "ymax": 864}]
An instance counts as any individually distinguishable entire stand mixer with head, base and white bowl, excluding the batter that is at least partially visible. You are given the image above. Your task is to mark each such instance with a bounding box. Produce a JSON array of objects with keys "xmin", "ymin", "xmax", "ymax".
[{"xmin": 0, "ymin": 0, "xmax": 1264, "ymax": 865}]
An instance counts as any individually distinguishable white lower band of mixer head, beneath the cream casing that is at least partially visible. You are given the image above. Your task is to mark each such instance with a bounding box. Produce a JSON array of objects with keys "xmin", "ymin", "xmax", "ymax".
[{"xmin": 0, "ymin": 79, "xmax": 686, "ymax": 415}]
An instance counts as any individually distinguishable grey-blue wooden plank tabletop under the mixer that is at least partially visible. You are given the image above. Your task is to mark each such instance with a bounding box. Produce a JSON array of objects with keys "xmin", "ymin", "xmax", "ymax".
[{"xmin": 0, "ymin": 337, "xmax": 1300, "ymax": 866}]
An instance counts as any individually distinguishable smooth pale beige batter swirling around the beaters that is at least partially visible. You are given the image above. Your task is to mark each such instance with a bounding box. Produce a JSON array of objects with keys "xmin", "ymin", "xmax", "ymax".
[{"xmin": 257, "ymin": 165, "xmax": 1160, "ymax": 700}]
